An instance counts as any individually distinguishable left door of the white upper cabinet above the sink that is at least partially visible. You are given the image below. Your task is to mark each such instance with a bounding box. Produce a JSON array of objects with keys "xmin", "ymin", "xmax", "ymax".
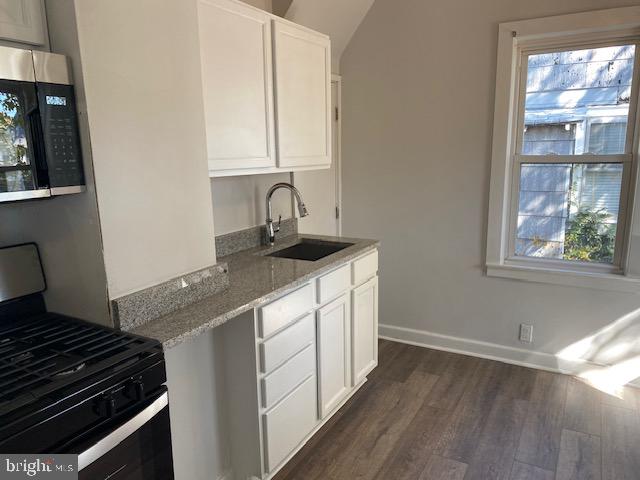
[{"xmin": 198, "ymin": 0, "xmax": 276, "ymax": 175}]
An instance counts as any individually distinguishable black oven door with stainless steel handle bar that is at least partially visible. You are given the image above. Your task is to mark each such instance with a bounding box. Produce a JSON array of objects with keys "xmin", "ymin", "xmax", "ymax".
[{"xmin": 78, "ymin": 390, "xmax": 174, "ymax": 480}]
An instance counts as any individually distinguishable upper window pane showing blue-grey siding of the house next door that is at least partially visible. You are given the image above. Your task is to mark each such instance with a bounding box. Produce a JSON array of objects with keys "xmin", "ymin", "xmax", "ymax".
[{"xmin": 521, "ymin": 45, "xmax": 635, "ymax": 155}]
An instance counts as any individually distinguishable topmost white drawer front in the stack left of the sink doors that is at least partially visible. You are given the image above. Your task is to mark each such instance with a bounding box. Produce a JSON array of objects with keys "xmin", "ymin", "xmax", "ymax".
[{"xmin": 258, "ymin": 285, "xmax": 314, "ymax": 338}]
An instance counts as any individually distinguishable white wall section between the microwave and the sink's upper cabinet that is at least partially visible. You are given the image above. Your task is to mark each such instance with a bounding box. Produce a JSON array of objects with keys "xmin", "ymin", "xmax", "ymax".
[{"xmin": 68, "ymin": 0, "xmax": 216, "ymax": 298}]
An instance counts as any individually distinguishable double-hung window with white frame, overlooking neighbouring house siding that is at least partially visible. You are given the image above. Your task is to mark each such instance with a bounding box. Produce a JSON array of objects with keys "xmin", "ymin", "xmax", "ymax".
[{"xmin": 487, "ymin": 7, "xmax": 640, "ymax": 288}]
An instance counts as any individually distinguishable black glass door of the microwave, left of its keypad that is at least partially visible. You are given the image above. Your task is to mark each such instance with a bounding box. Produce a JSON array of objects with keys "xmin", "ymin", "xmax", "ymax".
[{"xmin": 0, "ymin": 80, "xmax": 51, "ymax": 201}]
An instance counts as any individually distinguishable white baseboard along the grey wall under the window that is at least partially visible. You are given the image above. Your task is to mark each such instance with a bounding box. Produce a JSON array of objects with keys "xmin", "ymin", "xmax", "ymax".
[{"xmin": 378, "ymin": 324, "xmax": 640, "ymax": 388}]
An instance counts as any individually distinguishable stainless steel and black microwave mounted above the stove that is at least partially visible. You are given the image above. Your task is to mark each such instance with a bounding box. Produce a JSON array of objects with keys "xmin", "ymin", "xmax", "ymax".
[{"xmin": 0, "ymin": 47, "xmax": 85, "ymax": 202}]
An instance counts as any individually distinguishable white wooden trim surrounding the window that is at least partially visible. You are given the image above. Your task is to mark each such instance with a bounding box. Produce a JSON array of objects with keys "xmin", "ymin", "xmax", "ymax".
[{"xmin": 486, "ymin": 7, "xmax": 640, "ymax": 293}]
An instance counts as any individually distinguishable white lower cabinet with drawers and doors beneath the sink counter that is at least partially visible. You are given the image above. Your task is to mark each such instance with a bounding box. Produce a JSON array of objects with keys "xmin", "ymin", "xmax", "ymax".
[{"xmin": 220, "ymin": 250, "xmax": 378, "ymax": 480}]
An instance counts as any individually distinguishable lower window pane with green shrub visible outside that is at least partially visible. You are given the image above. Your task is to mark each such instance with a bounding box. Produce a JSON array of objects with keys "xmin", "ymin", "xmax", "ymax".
[{"xmin": 515, "ymin": 163, "xmax": 622, "ymax": 263}]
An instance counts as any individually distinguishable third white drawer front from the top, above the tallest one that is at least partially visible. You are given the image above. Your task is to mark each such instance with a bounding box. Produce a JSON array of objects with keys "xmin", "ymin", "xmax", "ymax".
[{"xmin": 261, "ymin": 345, "xmax": 316, "ymax": 409}]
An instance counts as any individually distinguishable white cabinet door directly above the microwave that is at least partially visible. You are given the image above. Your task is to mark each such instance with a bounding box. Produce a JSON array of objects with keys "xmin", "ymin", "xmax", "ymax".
[{"xmin": 0, "ymin": 0, "xmax": 46, "ymax": 45}]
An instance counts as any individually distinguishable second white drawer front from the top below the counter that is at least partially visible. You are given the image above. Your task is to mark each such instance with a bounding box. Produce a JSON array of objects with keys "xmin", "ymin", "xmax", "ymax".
[{"xmin": 260, "ymin": 313, "xmax": 315, "ymax": 373}]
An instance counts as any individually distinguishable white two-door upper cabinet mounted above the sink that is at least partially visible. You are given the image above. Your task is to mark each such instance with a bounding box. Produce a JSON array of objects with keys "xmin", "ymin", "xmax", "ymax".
[{"xmin": 199, "ymin": 0, "xmax": 331, "ymax": 176}]
